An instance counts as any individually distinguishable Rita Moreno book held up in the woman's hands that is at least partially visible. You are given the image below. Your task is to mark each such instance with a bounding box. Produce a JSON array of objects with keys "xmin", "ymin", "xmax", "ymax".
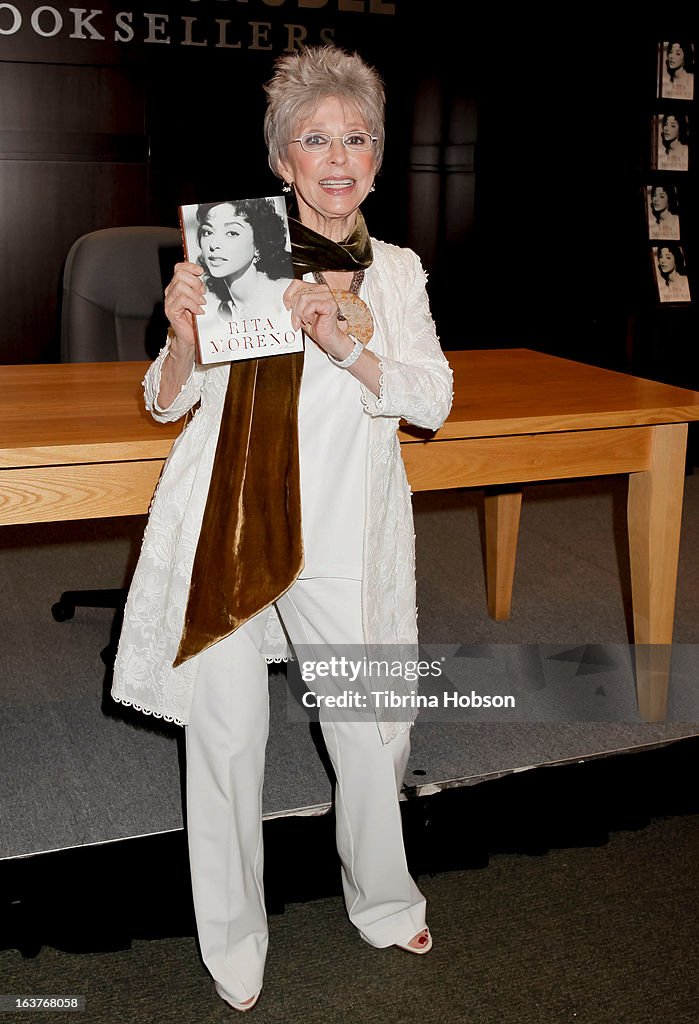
[{"xmin": 178, "ymin": 196, "xmax": 303, "ymax": 365}]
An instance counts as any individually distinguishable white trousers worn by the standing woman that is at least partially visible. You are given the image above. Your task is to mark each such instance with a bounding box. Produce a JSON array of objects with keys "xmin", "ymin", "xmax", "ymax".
[{"xmin": 185, "ymin": 579, "xmax": 425, "ymax": 1002}]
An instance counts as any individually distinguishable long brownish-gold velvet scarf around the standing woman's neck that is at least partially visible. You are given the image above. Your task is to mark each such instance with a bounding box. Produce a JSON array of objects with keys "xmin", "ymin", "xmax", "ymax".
[{"xmin": 173, "ymin": 211, "xmax": 372, "ymax": 667}]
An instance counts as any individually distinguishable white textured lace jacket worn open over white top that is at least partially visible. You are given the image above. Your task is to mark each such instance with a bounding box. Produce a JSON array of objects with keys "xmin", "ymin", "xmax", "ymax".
[{"xmin": 112, "ymin": 240, "xmax": 451, "ymax": 741}]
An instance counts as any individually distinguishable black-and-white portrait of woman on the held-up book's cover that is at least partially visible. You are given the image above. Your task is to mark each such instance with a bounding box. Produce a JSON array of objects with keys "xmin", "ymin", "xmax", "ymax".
[{"xmin": 196, "ymin": 199, "xmax": 290, "ymax": 322}]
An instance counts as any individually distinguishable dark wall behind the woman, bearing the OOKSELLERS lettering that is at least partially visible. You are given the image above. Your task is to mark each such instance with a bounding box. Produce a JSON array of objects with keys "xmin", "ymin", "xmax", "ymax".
[{"xmin": 0, "ymin": 8, "xmax": 699, "ymax": 378}]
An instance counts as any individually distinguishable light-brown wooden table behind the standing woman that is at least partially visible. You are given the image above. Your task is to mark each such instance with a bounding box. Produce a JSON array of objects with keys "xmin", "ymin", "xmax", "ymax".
[{"xmin": 0, "ymin": 349, "xmax": 699, "ymax": 721}]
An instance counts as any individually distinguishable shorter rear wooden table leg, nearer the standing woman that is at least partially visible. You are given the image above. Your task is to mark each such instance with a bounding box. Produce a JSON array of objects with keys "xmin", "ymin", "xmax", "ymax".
[{"xmin": 485, "ymin": 488, "xmax": 522, "ymax": 622}]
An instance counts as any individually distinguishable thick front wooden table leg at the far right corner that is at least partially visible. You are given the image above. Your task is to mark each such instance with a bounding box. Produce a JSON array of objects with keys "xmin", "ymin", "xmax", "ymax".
[{"xmin": 628, "ymin": 423, "xmax": 687, "ymax": 722}]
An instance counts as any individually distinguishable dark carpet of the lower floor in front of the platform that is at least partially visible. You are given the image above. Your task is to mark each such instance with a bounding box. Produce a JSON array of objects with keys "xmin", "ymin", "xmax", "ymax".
[{"xmin": 0, "ymin": 816, "xmax": 699, "ymax": 1024}]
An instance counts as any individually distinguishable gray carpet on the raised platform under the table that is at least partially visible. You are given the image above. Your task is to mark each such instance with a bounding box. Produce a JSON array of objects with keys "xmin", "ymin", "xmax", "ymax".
[{"xmin": 0, "ymin": 475, "xmax": 699, "ymax": 858}]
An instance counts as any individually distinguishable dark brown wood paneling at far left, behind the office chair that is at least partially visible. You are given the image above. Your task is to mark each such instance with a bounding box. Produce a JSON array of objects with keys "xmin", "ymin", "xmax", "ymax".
[{"xmin": 0, "ymin": 63, "xmax": 148, "ymax": 362}]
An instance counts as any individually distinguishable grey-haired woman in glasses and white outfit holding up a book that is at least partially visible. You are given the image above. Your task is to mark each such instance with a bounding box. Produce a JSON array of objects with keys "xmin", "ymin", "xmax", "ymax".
[{"xmin": 114, "ymin": 46, "xmax": 451, "ymax": 1011}]
